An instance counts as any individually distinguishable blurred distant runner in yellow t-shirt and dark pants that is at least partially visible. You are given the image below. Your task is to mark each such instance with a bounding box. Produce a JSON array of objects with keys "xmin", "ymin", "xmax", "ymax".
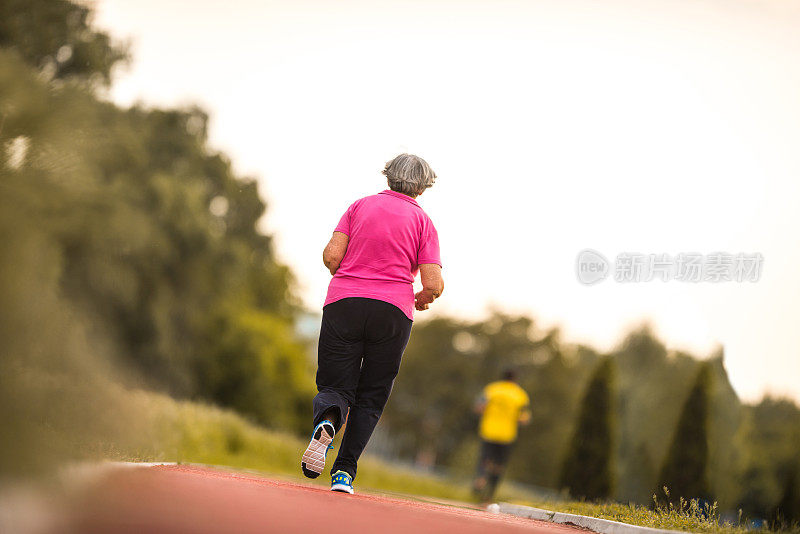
[{"xmin": 472, "ymin": 369, "xmax": 531, "ymax": 502}]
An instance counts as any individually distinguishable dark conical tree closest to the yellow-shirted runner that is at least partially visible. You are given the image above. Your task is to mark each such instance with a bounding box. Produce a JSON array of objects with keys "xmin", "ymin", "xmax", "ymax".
[{"xmin": 560, "ymin": 357, "xmax": 614, "ymax": 500}]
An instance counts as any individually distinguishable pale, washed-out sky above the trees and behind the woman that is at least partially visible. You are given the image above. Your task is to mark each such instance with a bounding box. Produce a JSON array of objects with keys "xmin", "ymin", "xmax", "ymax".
[{"xmin": 96, "ymin": 0, "xmax": 800, "ymax": 400}]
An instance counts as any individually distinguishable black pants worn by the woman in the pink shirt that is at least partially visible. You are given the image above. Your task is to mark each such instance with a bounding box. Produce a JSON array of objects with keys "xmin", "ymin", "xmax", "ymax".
[{"xmin": 314, "ymin": 298, "xmax": 412, "ymax": 477}]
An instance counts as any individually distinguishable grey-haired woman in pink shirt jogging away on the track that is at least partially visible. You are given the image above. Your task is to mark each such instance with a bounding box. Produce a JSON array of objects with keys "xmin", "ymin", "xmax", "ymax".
[{"xmin": 301, "ymin": 154, "xmax": 444, "ymax": 493}]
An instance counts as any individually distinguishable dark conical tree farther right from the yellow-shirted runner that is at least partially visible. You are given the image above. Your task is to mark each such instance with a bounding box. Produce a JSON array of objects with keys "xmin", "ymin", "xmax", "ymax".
[{"xmin": 656, "ymin": 362, "xmax": 712, "ymax": 502}]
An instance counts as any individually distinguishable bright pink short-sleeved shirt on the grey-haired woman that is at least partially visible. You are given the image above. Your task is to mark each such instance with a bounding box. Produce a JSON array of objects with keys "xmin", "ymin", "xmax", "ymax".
[{"xmin": 325, "ymin": 189, "xmax": 442, "ymax": 320}]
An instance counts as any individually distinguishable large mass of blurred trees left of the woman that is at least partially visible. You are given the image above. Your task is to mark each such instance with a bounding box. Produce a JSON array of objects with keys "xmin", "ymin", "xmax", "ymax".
[{"xmin": 0, "ymin": 0, "xmax": 313, "ymax": 478}]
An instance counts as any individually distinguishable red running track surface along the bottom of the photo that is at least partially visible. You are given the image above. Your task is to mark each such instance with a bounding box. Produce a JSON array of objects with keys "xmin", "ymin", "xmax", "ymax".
[{"xmin": 58, "ymin": 466, "xmax": 581, "ymax": 534}]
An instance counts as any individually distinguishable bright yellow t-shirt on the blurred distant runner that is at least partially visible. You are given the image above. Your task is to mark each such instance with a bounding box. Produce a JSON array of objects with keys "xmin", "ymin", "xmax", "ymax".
[{"xmin": 479, "ymin": 380, "xmax": 530, "ymax": 443}]
